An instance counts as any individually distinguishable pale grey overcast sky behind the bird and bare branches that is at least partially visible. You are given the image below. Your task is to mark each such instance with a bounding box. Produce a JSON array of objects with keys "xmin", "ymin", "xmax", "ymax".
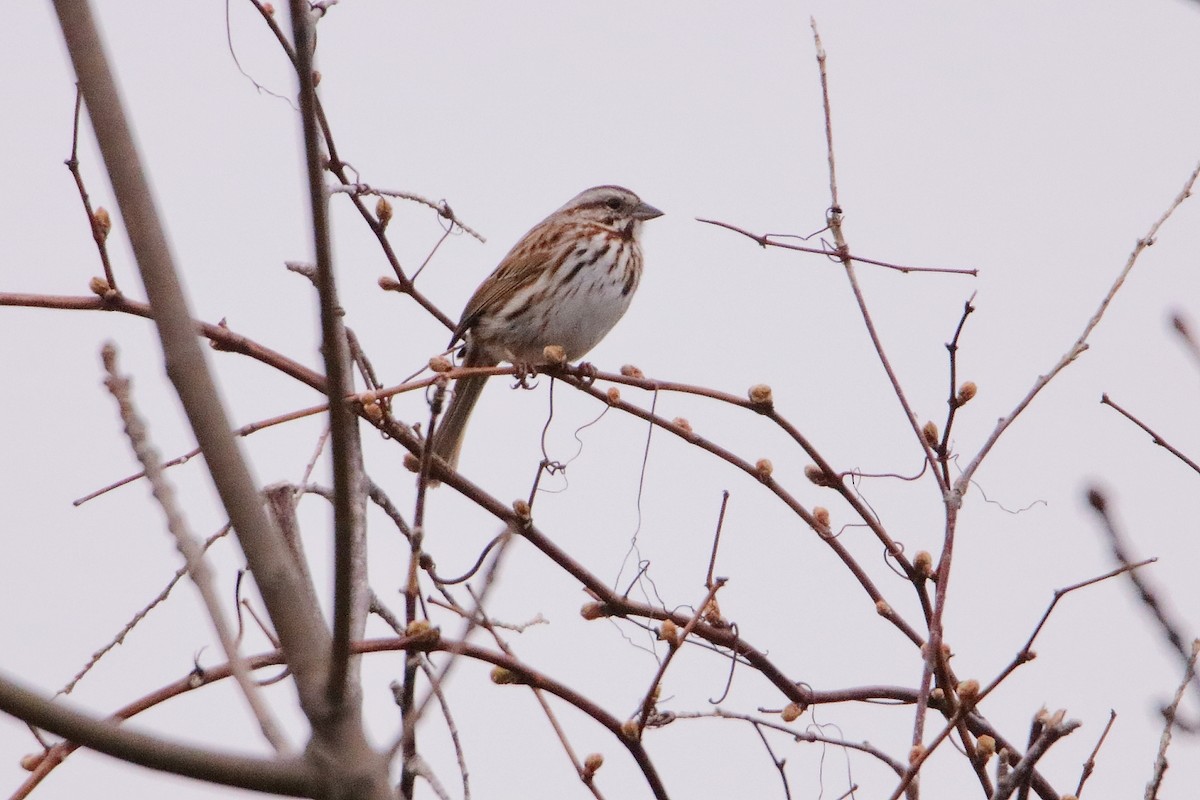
[{"xmin": 0, "ymin": 0, "xmax": 1200, "ymax": 800}]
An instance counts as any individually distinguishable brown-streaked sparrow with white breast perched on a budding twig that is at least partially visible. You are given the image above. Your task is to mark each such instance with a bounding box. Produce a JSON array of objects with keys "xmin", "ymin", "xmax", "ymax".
[{"xmin": 433, "ymin": 186, "xmax": 662, "ymax": 467}]
